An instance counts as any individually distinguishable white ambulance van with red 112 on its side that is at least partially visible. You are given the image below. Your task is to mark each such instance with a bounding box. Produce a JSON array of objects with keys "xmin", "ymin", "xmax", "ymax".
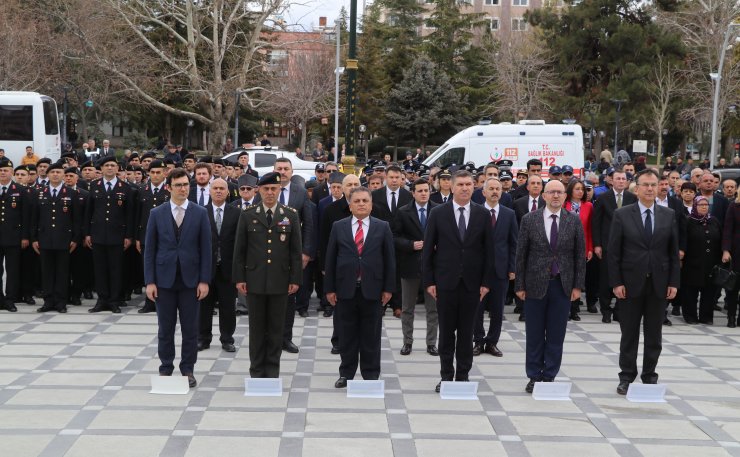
[{"xmin": 424, "ymin": 120, "xmax": 584, "ymax": 177}]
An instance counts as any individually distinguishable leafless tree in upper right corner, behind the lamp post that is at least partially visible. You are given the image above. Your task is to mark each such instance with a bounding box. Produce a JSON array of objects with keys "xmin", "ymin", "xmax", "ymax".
[{"xmin": 657, "ymin": 0, "xmax": 740, "ymax": 157}]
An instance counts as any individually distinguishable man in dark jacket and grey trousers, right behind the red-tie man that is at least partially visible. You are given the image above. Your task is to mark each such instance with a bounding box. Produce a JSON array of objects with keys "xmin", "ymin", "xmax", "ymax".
[{"xmin": 393, "ymin": 179, "xmax": 439, "ymax": 356}]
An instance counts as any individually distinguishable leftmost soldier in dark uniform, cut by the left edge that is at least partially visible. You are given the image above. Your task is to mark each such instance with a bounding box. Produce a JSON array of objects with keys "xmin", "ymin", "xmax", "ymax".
[{"xmin": 0, "ymin": 157, "xmax": 32, "ymax": 313}]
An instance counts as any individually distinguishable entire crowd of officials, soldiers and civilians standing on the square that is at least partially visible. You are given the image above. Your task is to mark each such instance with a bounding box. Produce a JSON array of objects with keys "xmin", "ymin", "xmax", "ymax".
[{"xmin": 0, "ymin": 141, "xmax": 740, "ymax": 394}]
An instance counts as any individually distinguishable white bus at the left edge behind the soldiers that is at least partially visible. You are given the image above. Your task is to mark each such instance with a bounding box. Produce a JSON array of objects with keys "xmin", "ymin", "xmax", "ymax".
[{"xmin": 0, "ymin": 92, "xmax": 62, "ymax": 165}]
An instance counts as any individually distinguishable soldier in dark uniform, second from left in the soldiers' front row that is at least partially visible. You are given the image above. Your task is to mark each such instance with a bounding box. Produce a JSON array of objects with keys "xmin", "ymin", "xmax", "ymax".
[{"xmin": 31, "ymin": 162, "xmax": 84, "ymax": 313}]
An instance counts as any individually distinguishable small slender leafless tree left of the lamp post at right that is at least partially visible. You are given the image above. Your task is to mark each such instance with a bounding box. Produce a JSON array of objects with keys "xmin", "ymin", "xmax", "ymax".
[{"xmin": 645, "ymin": 54, "xmax": 682, "ymax": 163}]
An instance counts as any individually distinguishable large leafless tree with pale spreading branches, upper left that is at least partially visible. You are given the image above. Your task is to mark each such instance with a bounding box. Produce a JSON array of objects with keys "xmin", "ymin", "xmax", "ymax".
[{"xmin": 42, "ymin": 0, "xmax": 289, "ymax": 151}]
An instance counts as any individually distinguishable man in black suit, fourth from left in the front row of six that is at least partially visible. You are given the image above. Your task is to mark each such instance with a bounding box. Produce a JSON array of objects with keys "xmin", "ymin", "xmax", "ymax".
[{"xmin": 422, "ymin": 170, "xmax": 491, "ymax": 392}]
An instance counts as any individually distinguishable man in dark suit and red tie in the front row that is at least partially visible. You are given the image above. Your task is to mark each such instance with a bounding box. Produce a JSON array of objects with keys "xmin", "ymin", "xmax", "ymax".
[{"xmin": 324, "ymin": 187, "xmax": 396, "ymax": 389}]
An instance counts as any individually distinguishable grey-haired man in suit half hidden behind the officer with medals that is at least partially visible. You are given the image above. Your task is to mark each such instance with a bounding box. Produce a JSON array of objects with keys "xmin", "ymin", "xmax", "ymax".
[{"xmin": 274, "ymin": 157, "xmax": 316, "ymax": 353}]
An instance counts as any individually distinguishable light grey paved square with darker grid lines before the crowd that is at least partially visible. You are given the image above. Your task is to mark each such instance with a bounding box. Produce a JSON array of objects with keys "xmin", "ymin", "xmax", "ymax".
[{"xmin": 0, "ymin": 300, "xmax": 740, "ymax": 457}]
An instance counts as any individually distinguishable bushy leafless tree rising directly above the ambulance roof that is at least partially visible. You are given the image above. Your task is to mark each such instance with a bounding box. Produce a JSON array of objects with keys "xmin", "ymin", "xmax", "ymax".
[{"xmin": 480, "ymin": 32, "xmax": 562, "ymax": 122}]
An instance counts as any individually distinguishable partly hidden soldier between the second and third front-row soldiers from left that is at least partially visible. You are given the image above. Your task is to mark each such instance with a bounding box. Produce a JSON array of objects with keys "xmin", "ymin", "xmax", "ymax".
[{"xmin": 64, "ymin": 167, "xmax": 93, "ymax": 306}]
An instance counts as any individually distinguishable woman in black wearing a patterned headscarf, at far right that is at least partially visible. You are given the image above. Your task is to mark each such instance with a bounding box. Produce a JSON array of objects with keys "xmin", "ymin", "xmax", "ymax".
[{"xmin": 681, "ymin": 195, "xmax": 722, "ymax": 325}]
